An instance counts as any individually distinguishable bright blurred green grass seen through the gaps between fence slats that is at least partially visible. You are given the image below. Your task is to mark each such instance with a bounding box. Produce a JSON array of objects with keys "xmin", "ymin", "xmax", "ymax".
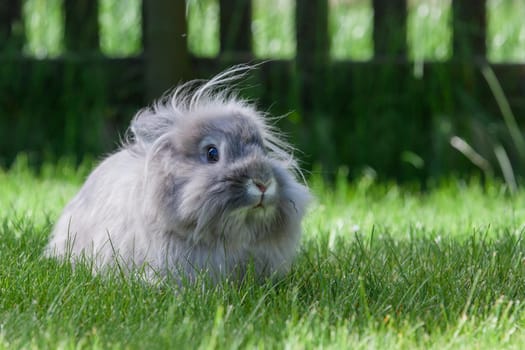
[{"xmin": 24, "ymin": 0, "xmax": 525, "ymax": 62}]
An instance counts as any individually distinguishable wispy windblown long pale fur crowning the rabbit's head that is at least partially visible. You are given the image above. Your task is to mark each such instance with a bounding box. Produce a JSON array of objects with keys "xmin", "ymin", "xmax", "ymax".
[{"xmin": 123, "ymin": 64, "xmax": 305, "ymax": 182}]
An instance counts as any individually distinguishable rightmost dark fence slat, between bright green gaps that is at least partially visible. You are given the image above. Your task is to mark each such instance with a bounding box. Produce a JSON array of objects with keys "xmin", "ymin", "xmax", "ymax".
[{"xmin": 452, "ymin": 0, "xmax": 487, "ymax": 58}]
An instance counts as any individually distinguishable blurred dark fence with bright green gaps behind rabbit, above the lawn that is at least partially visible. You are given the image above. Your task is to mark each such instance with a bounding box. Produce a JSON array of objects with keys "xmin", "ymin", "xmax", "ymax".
[{"xmin": 0, "ymin": 0, "xmax": 525, "ymax": 186}]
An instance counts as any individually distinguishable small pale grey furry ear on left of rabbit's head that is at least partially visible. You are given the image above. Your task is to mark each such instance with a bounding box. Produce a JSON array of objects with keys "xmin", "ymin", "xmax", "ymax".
[{"xmin": 130, "ymin": 108, "xmax": 174, "ymax": 144}]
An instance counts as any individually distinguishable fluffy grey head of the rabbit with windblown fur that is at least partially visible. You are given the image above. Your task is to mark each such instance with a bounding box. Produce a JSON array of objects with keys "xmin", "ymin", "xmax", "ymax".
[{"xmin": 127, "ymin": 67, "xmax": 309, "ymax": 248}]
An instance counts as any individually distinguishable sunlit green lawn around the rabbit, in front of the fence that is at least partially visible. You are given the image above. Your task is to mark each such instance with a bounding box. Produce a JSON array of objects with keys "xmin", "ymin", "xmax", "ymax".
[{"xmin": 0, "ymin": 157, "xmax": 525, "ymax": 349}]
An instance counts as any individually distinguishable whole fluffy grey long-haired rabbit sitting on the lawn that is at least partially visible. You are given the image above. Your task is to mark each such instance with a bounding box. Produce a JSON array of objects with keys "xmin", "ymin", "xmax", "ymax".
[{"xmin": 45, "ymin": 66, "xmax": 312, "ymax": 281}]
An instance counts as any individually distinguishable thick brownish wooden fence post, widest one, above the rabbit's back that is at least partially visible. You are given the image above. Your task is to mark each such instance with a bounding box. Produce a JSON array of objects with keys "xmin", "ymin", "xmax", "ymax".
[{"xmin": 142, "ymin": 0, "xmax": 192, "ymax": 101}]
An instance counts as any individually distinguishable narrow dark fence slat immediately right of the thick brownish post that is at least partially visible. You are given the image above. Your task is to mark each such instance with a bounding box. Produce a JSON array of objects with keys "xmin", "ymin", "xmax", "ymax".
[{"xmin": 219, "ymin": 0, "xmax": 252, "ymax": 57}]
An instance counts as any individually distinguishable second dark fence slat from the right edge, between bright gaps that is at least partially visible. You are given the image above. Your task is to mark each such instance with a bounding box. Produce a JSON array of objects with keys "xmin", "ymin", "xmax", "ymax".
[{"xmin": 372, "ymin": 0, "xmax": 407, "ymax": 58}]
